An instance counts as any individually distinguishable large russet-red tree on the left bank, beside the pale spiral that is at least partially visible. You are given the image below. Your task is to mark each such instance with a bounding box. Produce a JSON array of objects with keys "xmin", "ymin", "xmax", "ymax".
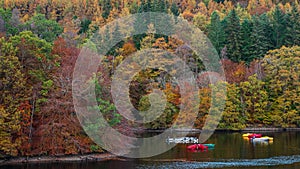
[{"xmin": 32, "ymin": 38, "xmax": 93, "ymax": 155}]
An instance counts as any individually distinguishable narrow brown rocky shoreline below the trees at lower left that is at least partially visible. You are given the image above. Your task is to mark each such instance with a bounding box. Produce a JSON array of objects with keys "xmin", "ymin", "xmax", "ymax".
[{"xmin": 0, "ymin": 153, "xmax": 123, "ymax": 166}]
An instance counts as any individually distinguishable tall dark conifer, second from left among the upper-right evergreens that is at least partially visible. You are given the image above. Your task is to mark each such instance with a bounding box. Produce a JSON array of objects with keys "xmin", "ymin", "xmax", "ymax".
[{"xmin": 225, "ymin": 9, "xmax": 242, "ymax": 62}]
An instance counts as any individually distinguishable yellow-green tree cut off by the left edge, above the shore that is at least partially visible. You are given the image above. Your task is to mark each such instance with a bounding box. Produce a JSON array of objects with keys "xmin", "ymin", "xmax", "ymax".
[{"xmin": 0, "ymin": 38, "xmax": 28, "ymax": 156}]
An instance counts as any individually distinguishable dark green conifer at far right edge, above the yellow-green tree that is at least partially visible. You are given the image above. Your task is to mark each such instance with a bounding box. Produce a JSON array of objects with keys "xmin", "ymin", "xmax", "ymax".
[{"xmin": 285, "ymin": 5, "xmax": 300, "ymax": 46}]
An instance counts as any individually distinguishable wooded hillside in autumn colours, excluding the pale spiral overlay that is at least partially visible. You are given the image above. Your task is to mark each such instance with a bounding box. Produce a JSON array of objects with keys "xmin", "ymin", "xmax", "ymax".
[{"xmin": 0, "ymin": 0, "xmax": 300, "ymax": 157}]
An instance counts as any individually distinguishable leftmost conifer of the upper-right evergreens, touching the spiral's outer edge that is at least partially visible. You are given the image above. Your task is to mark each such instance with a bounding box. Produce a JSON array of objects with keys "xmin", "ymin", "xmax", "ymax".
[{"xmin": 208, "ymin": 12, "xmax": 226, "ymax": 53}]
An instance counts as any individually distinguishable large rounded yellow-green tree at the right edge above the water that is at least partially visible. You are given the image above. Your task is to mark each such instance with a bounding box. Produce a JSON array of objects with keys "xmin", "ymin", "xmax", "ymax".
[{"xmin": 263, "ymin": 46, "xmax": 300, "ymax": 127}]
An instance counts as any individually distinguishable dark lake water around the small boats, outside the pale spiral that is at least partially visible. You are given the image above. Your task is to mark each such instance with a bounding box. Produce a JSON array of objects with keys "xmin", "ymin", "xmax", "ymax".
[{"xmin": 0, "ymin": 132, "xmax": 300, "ymax": 169}]
